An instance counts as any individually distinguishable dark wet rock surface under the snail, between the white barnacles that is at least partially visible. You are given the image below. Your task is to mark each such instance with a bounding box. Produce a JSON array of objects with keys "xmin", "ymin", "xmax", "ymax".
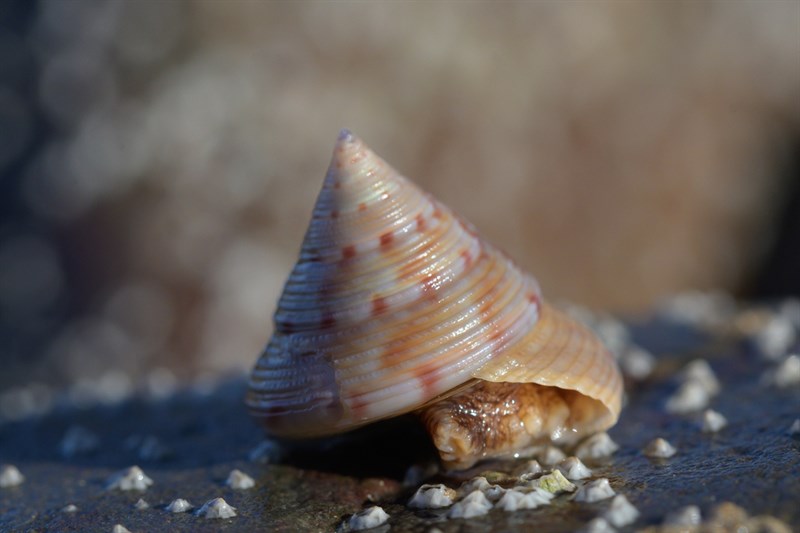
[{"xmin": 0, "ymin": 310, "xmax": 800, "ymax": 533}]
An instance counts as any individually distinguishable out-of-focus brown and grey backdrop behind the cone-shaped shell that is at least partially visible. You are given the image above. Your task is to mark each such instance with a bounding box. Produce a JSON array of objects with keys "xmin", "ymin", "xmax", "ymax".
[{"xmin": 0, "ymin": 0, "xmax": 800, "ymax": 410}]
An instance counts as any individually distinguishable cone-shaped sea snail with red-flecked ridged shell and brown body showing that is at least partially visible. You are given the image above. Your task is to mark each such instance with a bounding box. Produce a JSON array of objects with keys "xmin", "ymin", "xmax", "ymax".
[{"xmin": 247, "ymin": 130, "xmax": 622, "ymax": 468}]
